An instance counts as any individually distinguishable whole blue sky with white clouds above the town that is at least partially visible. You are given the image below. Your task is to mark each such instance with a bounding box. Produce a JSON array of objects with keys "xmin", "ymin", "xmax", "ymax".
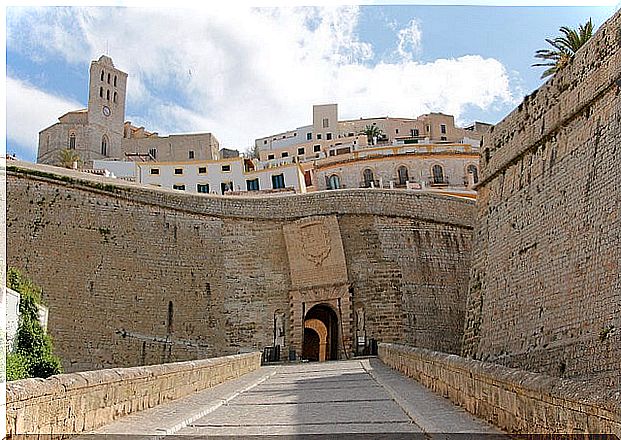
[{"xmin": 5, "ymin": 0, "xmax": 620, "ymax": 161}]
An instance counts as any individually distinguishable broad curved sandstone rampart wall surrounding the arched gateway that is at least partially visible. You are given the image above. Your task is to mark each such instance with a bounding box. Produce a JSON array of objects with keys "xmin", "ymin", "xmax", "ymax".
[{"xmin": 7, "ymin": 163, "xmax": 474, "ymax": 372}]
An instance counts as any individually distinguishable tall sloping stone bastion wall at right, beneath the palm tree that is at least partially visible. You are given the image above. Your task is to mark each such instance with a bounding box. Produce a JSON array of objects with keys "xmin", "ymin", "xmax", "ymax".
[{"xmin": 463, "ymin": 8, "xmax": 621, "ymax": 387}]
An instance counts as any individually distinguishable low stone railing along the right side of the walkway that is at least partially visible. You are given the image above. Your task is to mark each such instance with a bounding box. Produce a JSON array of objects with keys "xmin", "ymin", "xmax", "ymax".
[{"xmin": 379, "ymin": 344, "xmax": 621, "ymax": 438}]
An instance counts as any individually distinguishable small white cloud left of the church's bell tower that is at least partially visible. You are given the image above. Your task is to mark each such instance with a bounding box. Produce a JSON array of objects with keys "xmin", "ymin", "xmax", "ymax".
[{"xmin": 6, "ymin": 77, "xmax": 82, "ymax": 156}]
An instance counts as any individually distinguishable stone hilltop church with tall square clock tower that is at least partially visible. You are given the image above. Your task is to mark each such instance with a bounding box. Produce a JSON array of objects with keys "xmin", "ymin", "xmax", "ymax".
[{"xmin": 37, "ymin": 55, "xmax": 219, "ymax": 168}]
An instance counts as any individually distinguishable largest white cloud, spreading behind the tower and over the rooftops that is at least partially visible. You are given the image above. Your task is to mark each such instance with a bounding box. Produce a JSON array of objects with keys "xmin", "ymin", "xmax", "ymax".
[{"xmin": 7, "ymin": 6, "xmax": 513, "ymax": 155}]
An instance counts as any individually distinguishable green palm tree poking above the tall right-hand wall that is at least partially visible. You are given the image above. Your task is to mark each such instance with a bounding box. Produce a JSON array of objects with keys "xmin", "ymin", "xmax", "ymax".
[{"xmin": 533, "ymin": 18, "xmax": 593, "ymax": 78}]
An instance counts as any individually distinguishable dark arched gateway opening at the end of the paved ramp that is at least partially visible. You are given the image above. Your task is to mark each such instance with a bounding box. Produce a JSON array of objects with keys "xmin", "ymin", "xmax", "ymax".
[{"xmin": 302, "ymin": 304, "xmax": 339, "ymax": 361}]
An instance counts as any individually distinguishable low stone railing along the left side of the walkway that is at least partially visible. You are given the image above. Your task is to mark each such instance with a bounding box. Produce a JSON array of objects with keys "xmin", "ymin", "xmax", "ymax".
[{"xmin": 6, "ymin": 352, "xmax": 261, "ymax": 438}]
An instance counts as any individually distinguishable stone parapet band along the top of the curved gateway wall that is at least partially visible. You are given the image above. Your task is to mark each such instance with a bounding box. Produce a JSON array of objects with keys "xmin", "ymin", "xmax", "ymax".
[{"xmin": 7, "ymin": 161, "xmax": 474, "ymax": 228}]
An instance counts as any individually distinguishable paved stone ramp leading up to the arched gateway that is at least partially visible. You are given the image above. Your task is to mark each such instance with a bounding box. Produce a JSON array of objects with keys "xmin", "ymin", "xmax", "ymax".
[{"xmin": 95, "ymin": 359, "xmax": 504, "ymax": 440}]
